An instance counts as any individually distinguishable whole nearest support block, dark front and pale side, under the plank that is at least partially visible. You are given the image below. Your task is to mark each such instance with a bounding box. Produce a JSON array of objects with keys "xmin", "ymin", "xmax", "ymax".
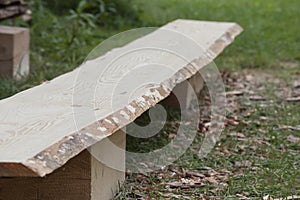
[{"xmin": 0, "ymin": 130, "xmax": 126, "ymax": 200}]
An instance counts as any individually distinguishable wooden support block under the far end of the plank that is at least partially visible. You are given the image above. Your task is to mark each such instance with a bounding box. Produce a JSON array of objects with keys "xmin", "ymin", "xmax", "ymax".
[{"xmin": 161, "ymin": 73, "xmax": 204, "ymax": 111}]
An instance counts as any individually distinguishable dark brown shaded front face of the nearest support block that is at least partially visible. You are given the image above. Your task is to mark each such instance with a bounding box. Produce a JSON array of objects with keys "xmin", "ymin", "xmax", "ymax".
[{"xmin": 0, "ymin": 150, "xmax": 91, "ymax": 200}]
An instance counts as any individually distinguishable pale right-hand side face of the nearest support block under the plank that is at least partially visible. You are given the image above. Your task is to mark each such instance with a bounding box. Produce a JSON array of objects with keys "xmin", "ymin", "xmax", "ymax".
[{"xmin": 90, "ymin": 129, "xmax": 126, "ymax": 200}]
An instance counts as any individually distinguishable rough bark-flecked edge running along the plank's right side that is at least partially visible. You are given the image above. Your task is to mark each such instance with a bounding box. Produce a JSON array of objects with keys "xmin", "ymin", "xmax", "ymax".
[{"xmin": 0, "ymin": 23, "xmax": 243, "ymax": 177}]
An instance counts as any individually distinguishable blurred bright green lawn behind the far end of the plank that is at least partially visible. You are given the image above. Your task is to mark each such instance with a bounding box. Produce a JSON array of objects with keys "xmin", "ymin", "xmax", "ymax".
[{"xmin": 132, "ymin": 0, "xmax": 300, "ymax": 69}]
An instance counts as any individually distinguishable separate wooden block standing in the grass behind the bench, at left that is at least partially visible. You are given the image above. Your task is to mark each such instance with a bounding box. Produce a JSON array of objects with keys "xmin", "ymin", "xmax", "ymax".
[{"xmin": 0, "ymin": 26, "xmax": 30, "ymax": 79}]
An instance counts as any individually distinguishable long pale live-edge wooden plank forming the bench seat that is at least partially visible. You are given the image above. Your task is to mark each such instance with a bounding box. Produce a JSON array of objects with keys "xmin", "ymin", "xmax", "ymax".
[{"xmin": 0, "ymin": 20, "xmax": 242, "ymax": 176}]
